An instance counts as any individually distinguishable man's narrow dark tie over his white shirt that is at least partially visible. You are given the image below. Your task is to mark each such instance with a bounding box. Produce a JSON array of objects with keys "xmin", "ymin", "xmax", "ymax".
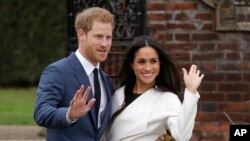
[{"xmin": 94, "ymin": 68, "xmax": 101, "ymax": 123}]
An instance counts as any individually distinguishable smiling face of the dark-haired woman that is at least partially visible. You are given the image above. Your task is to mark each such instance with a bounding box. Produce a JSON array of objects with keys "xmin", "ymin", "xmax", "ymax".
[{"xmin": 131, "ymin": 46, "xmax": 160, "ymax": 86}]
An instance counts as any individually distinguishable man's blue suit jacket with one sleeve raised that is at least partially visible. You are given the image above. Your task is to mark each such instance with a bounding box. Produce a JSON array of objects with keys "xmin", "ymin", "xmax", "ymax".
[{"xmin": 34, "ymin": 53, "xmax": 112, "ymax": 141}]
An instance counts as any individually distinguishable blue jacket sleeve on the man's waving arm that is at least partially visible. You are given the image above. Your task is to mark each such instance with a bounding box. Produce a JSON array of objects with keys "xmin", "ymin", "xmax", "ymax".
[{"xmin": 34, "ymin": 65, "xmax": 71, "ymax": 128}]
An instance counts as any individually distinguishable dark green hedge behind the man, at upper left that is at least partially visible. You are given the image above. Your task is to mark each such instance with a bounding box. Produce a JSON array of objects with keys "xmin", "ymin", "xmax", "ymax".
[{"xmin": 0, "ymin": 0, "xmax": 67, "ymax": 87}]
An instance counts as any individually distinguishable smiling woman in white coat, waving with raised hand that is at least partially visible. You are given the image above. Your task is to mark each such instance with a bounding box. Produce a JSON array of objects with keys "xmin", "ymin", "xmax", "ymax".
[{"xmin": 109, "ymin": 37, "xmax": 204, "ymax": 141}]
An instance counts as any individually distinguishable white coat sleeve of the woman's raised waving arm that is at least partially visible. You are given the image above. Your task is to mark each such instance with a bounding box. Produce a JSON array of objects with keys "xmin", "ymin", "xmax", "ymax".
[{"xmin": 167, "ymin": 89, "xmax": 200, "ymax": 141}]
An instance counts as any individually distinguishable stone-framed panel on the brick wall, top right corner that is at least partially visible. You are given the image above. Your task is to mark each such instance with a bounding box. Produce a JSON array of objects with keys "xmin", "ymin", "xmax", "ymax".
[{"xmin": 203, "ymin": 0, "xmax": 250, "ymax": 31}]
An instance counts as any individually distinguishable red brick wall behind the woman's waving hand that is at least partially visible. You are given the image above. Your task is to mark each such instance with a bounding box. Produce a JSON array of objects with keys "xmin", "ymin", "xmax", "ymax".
[{"xmin": 147, "ymin": 0, "xmax": 250, "ymax": 141}]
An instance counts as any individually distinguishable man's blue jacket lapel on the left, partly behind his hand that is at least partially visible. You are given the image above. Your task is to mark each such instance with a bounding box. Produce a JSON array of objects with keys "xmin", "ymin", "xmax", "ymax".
[{"xmin": 68, "ymin": 53, "xmax": 97, "ymax": 127}]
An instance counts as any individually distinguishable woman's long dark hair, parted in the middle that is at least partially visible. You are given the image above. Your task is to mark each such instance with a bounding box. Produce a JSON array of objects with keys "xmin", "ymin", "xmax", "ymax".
[{"xmin": 114, "ymin": 36, "xmax": 181, "ymax": 121}]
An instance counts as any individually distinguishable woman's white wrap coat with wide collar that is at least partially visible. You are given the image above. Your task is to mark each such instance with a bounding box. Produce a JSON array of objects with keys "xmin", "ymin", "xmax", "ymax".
[{"xmin": 109, "ymin": 87, "xmax": 199, "ymax": 141}]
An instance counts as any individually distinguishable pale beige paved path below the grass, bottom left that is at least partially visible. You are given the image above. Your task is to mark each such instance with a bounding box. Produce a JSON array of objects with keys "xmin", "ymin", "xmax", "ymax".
[{"xmin": 0, "ymin": 125, "xmax": 45, "ymax": 141}]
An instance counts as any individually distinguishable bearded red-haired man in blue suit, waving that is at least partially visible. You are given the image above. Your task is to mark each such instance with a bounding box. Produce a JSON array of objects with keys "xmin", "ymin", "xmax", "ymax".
[{"xmin": 34, "ymin": 7, "xmax": 114, "ymax": 141}]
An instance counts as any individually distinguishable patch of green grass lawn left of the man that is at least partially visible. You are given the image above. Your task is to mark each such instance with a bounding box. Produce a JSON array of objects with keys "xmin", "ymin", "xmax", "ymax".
[{"xmin": 0, "ymin": 88, "xmax": 36, "ymax": 125}]
